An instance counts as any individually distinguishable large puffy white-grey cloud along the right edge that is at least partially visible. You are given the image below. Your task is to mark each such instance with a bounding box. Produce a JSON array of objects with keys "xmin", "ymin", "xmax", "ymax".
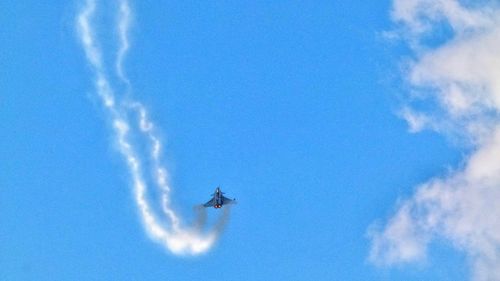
[{"xmin": 370, "ymin": 0, "xmax": 500, "ymax": 280}]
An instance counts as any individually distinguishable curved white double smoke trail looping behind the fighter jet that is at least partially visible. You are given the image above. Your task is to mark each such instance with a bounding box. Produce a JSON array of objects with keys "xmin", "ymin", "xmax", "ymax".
[{"xmin": 76, "ymin": 0, "xmax": 230, "ymax": 254}]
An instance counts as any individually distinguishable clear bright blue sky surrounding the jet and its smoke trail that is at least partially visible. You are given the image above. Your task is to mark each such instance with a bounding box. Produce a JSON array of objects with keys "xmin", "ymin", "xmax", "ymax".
[{"xmin": 0, "ymin": 0, "xmax": 498, "ymax": 280}]
